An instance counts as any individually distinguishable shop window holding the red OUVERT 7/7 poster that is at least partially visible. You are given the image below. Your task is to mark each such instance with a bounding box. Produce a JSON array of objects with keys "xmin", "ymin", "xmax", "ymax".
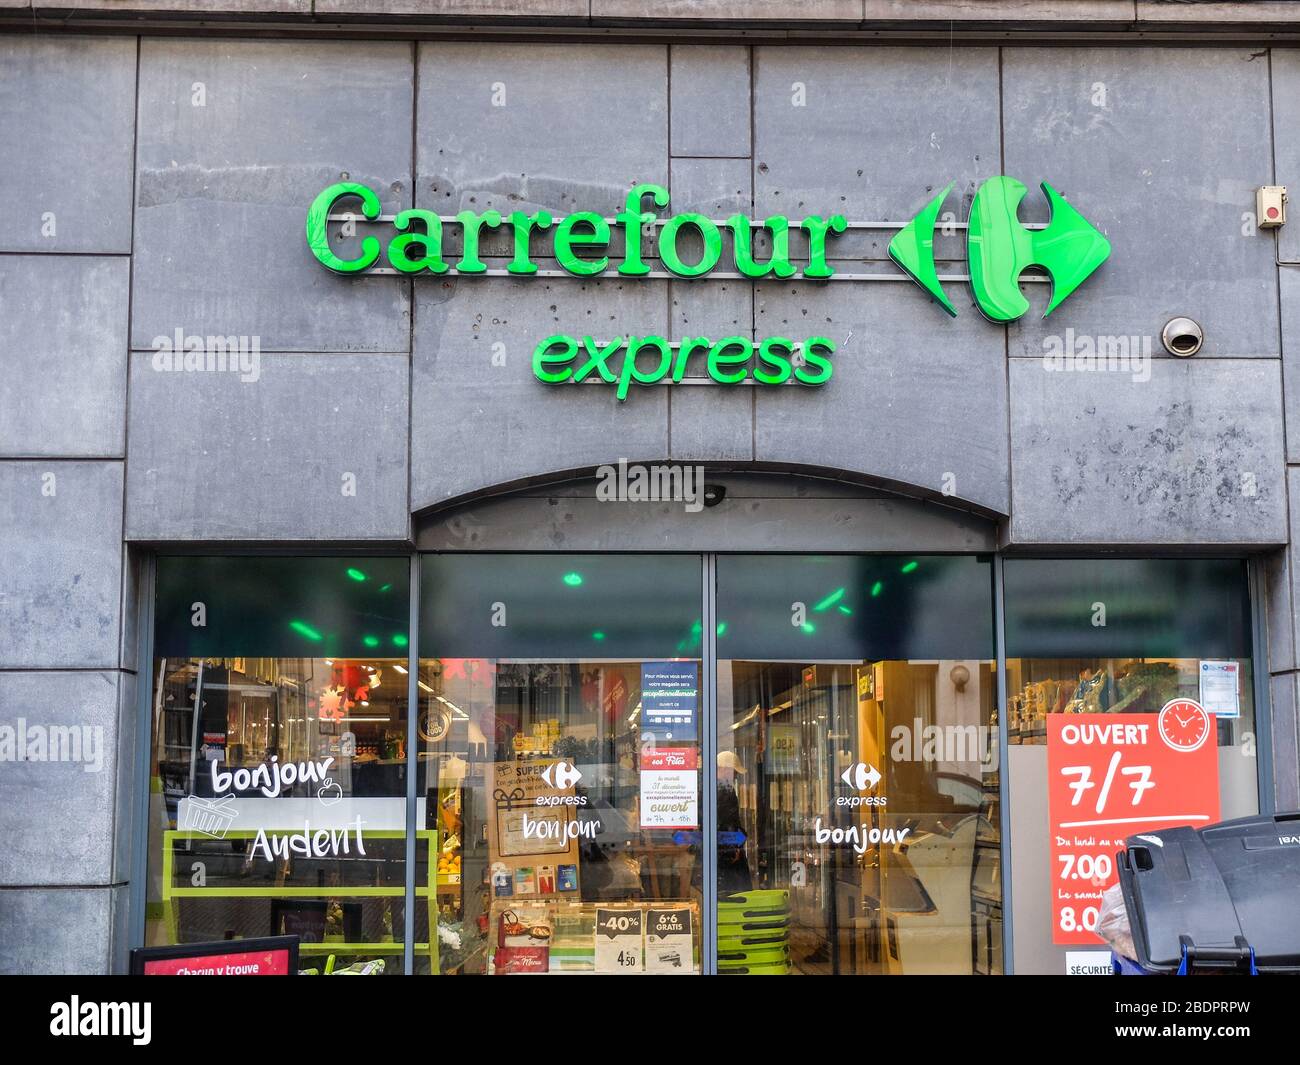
[{"xmin": 1004, "ymin": 559, "xmax": 1258, "ymax": 974}]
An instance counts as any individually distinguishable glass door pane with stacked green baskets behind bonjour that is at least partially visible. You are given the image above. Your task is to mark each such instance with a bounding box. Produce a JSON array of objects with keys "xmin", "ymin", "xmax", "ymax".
[{"xmin": 716, "ymin": 555, "xmax": 1002, "ymax": 974}]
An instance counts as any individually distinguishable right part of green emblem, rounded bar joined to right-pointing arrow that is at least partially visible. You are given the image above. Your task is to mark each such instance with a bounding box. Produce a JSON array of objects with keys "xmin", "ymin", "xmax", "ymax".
[{"xmin": 966, "ymin": 177, "xmax": 1110, "ymax": 321}]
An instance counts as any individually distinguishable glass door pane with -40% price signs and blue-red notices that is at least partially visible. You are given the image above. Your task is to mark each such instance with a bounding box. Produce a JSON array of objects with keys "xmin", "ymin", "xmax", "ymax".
[{"xmin": 416, "ymin": 555, "xmax": 702, "ymax": 975}]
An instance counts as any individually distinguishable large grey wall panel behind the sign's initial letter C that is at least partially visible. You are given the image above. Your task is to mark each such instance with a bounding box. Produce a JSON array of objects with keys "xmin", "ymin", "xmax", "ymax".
[{"xmin": 131, "ymin": 40, "xmax": 415, "ymax": 351}]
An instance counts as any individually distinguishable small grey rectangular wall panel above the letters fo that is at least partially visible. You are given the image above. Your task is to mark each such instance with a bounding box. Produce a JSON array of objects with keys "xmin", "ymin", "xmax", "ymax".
[{"xmin": 668, "ymin": 44, "xmax": 750, "ymax": 156}]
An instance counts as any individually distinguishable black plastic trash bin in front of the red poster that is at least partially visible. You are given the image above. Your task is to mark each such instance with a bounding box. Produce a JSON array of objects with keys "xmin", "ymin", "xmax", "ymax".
[{"xmin": 1117, "ymin": 813, "xmax": 1300, "ymax": 975}]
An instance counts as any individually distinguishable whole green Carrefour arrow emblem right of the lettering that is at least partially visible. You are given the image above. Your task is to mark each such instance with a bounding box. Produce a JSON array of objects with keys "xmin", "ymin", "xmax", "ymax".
[{"xmin": 889, "ymin": 177, "xmax": 1110, "ymax": 321}]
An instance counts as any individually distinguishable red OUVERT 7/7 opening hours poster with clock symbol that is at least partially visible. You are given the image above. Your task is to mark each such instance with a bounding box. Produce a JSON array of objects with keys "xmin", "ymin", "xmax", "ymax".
[{"xmin": 1048, "ymin": 700, "xmax": 1218, "ymax": 945}]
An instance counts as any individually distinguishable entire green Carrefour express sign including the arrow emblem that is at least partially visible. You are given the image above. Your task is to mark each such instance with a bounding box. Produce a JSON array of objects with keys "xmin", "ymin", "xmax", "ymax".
[{"xmin": 307, "ymin": 177, "xmax": 1110, "ymax": 401}]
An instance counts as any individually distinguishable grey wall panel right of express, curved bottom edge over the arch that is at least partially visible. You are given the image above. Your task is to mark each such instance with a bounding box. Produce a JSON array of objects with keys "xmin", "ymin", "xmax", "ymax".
[{"xmin": 754, "ymin": 282, "xmax": 1010, "ymax": 514}]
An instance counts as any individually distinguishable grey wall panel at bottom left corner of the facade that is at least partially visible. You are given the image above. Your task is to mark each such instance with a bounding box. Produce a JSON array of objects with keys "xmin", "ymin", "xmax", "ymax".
[{"xmin": 0, "ymin": 887, "xmax": 126, "ymax": 977}]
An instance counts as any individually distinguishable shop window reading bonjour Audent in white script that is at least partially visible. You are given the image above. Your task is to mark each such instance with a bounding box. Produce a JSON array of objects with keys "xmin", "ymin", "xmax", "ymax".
[{"xmin": 146, "ymin": 557, "xmax": 408, "ymax": 973}]
